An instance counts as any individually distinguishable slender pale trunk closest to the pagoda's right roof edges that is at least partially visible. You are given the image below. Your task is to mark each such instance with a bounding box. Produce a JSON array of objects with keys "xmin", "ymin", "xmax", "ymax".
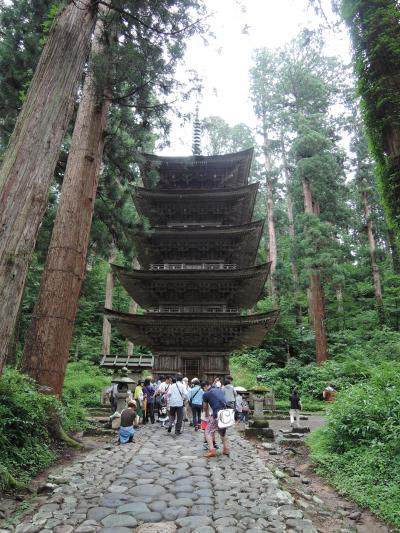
[{"xmin": 264, "ymin": 137, "xmax": 279, "ymax": 304}]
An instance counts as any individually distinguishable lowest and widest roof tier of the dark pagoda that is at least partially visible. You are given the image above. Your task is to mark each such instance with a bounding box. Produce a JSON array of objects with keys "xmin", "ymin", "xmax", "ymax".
[{"xmin": 105, "ymin": 309, "xmax": 279, "ymax": 354}]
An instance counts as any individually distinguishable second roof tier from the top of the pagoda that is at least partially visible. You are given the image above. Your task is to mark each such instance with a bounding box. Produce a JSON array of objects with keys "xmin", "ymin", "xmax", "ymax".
[{"xmin": 134, "ymin": 183, "xmax": 258, "ymax": 226}]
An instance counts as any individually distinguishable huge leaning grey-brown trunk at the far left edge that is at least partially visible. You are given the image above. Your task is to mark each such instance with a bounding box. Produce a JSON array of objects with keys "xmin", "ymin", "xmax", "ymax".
[{"xmin": 0, "ymin": 0, "xmax": 96, "ymax": 374}]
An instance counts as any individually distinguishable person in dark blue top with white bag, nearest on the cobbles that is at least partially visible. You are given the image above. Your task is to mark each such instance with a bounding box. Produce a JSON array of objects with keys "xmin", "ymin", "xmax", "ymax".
[{"xmin": 201, "ymin": 381, "xmax": 229, "ymax": 457}]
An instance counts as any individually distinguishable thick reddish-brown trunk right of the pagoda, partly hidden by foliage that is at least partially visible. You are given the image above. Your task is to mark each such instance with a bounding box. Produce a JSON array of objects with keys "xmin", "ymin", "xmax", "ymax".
[{"xmin": 303, "ymin": 179, "xmax": 328, "ymax": 365}]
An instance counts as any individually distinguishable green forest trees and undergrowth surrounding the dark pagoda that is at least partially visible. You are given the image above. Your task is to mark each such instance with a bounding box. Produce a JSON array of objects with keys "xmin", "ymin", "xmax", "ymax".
[{"xmin": 0, "ymin": 0, "xmax": 400, "ymax": 526}]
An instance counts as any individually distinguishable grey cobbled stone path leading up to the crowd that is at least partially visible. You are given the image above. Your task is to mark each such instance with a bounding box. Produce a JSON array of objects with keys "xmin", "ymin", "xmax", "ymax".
[{"xmin": 9, "ymin": 425, "xmax": 317, "ymax": 533}]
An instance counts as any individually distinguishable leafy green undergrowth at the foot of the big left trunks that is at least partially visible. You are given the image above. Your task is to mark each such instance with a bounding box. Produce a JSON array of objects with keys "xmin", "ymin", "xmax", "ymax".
[{"xmin": 0, "ymin": 362, "xmax": 110, "ymax": 489}]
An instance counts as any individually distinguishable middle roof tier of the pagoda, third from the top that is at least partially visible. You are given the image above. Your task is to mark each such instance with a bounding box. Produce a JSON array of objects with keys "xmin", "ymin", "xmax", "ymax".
[{"xmin": 133, "ymin": 220, "xmax": 264, "ymax": 269}]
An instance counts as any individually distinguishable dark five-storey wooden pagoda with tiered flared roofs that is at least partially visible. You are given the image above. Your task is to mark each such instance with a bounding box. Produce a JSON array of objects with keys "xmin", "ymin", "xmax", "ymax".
[{"xmin": 106, "ymin": 149, "xmax": 277, "ymax": 378}]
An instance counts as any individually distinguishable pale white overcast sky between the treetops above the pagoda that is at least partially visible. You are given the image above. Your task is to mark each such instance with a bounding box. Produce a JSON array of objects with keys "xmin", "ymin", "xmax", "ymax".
[{"xmin": 159, "ymin": 0, "xmax": 350, "ymax": 156}]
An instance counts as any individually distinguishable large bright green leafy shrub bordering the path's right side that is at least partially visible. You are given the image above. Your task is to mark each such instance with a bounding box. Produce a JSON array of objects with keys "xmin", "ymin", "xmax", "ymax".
[{"xmin": 308, "ymin": 363, "xmax": 400, "ymax": 527}]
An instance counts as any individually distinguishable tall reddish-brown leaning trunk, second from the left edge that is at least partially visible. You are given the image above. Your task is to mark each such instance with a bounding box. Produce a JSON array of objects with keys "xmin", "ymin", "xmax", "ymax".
[{"xmin": 21, "ymin": 13, "xmax": 109, "ymax": 395}]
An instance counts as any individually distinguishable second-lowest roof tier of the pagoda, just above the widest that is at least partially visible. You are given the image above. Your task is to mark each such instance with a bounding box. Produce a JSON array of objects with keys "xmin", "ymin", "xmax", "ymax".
[{"xmin": 112, "ymin": 263, "xmax": 270, "ymax": 309}]
